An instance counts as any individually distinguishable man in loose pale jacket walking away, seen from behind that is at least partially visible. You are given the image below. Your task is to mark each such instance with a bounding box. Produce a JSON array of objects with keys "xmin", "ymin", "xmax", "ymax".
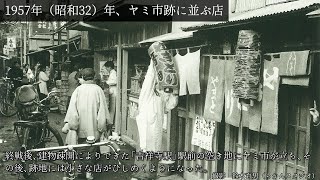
[{"xmin": 62, "ymin": 68, "xmax": 112, "ymax": 179}]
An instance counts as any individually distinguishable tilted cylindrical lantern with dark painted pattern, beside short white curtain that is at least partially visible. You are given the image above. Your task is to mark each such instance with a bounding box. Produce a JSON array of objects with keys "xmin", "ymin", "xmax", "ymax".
[{"xmin": 148, "ymin": 42, "xmax": 179, "ymax": 94}]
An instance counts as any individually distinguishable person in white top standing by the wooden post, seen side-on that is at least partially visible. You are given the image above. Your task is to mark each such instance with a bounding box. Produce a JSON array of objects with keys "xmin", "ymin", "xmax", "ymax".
[{"xmin": 104, "ymin": 61, "xmax": 117, "ymax": 132}]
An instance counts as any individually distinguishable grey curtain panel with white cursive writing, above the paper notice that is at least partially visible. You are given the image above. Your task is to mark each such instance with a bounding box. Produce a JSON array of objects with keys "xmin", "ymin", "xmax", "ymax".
[{"xmin": 203, "ymin": 57, "xmax": 225, "ymax": 122}]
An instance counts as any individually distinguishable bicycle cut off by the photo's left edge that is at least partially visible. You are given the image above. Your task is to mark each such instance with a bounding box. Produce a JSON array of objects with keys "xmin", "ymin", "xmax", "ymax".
[{"xmin": 0, "ymin": 77, "xmax": 17, "ymax": 117}]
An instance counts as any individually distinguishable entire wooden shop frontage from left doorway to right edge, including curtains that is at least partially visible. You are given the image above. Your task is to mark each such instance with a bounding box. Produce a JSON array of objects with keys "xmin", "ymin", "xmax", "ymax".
[{"xmin": 58, "ymin": 0, "xmax": 320, "ymax": 180}]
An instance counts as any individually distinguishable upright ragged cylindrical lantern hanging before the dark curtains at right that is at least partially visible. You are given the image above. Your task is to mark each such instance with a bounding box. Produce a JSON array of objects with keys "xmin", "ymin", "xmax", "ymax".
[{"xmin": 232, "ymin": 30, "xmax": 261, "ymax": 100}]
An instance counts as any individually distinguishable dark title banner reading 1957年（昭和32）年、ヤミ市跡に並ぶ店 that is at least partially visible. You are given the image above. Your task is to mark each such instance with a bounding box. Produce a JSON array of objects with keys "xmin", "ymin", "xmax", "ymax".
[{"xmin": 4, "ymin": 0, "xmax": 229, "ymax": 21}]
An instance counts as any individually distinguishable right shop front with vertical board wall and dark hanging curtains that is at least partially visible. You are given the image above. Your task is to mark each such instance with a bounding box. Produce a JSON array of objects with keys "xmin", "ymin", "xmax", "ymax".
[{"xmin": 177, "ymin": 1, "xmax": 319, "ymax": 179}]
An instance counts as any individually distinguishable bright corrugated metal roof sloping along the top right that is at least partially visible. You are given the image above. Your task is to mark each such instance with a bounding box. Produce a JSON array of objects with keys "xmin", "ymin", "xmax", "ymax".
[{"xmin": 182, "ymin": 0, "xmax": 320, "ymax": 31}]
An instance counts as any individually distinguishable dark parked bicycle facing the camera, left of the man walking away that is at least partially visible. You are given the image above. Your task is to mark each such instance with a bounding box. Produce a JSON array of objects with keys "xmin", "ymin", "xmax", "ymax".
[{"xmin": 13, "ymin": 89, "xmax": 64, "ymax": 178}]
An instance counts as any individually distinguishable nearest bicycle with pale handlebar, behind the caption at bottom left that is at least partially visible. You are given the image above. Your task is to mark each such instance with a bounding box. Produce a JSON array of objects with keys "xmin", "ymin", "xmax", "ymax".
[{"xmin": 26, "ymin": 136, "xmax": 121, "ymax": 180}]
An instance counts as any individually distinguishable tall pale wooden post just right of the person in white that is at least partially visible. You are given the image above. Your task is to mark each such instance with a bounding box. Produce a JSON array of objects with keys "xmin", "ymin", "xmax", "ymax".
[{"xmin": 115, "ymin": 32, "xmax": 122, "ymax": 133}]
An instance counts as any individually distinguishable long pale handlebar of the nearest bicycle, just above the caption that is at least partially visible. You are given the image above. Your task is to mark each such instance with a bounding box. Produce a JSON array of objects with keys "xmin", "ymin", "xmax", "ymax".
[{"xmin": 27, "ymin": 141, "xmax": 120, "ymax": 152}]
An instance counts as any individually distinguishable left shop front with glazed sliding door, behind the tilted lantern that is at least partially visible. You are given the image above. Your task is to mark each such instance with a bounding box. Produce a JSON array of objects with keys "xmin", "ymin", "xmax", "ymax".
[{"xmin": 68, "ymin": 22, "xmax": 176, "ymax": 149}]
